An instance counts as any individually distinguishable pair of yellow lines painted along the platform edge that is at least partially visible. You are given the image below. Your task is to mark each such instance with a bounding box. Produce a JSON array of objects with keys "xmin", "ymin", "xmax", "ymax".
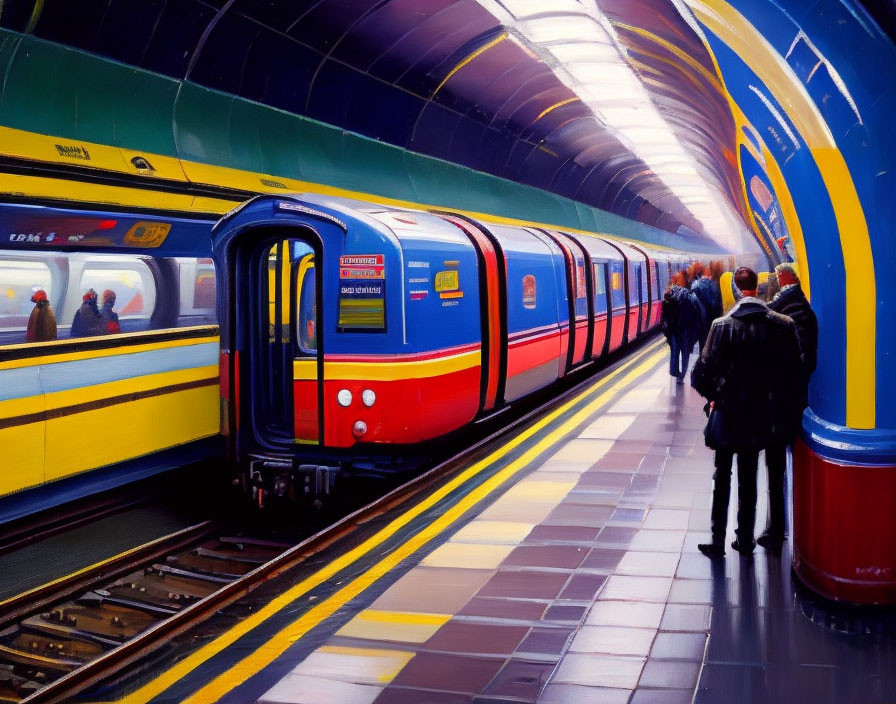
[{"xmin": 123, "ymin": 341, "xmax": 666, "ymax": 704}]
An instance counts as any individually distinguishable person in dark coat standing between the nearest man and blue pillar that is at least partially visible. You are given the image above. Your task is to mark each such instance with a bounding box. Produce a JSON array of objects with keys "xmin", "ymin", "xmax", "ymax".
[{"xmin": 756, "ymin": 264, "xmax": 818, "ymax": 550}]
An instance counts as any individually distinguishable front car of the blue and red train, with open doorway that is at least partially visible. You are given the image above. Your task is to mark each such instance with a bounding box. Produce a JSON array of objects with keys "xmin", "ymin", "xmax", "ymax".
[{"xmin": 213, "ymin": 196, "xmax": 482, "ymax": 503}]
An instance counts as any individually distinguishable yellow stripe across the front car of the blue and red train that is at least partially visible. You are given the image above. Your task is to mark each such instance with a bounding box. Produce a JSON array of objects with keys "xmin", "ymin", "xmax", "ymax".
[{"xmin": 292, "ymin": 350, "xmax": 482, "ymax": 381}]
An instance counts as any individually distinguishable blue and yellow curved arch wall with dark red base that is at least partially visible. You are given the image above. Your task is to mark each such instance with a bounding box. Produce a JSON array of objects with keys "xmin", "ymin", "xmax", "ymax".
[{"xmin": 687, "ymin": 0, "xmax": 896, "ymax": 602}]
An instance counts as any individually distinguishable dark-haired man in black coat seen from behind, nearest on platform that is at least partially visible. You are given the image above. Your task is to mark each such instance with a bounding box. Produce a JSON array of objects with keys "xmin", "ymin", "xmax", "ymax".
[{"xmin": 691, "ymin": 267, "xmax": 801, "ymax": 556}]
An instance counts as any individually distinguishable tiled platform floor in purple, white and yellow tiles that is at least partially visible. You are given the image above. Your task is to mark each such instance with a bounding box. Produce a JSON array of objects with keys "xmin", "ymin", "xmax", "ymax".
[{"xmin": 252, "ymin": 354, "xmax": 896, "ymax": 704}]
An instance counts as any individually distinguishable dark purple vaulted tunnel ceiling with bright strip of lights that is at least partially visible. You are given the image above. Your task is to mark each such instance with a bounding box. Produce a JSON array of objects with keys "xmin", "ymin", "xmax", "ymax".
[{"xmin": 0, "ymin": 0, "xmax": 764, "ymax": 250}]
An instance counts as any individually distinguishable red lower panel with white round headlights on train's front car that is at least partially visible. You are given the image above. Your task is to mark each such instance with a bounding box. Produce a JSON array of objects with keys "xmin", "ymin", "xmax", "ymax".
[{"xmin": 324, "ymin": 366, "xmax": 480, "ymax": 447}]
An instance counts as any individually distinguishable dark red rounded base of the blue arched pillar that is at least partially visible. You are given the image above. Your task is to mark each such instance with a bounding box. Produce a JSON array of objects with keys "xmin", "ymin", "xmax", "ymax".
[{"xmin": 793, "ymin": 440, "xmax": 896, "ymax": 604}]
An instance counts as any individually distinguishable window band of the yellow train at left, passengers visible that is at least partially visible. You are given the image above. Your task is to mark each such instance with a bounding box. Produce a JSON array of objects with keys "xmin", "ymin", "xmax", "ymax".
[{"xmin": 0, "ymin": 251, "xmax": 216, "ymax": 346}]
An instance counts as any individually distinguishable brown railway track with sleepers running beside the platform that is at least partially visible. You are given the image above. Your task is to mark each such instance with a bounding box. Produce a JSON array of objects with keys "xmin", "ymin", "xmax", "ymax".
[{"xmin": 0, "ymin": 338, "xmax": 656, "ymax": 704}]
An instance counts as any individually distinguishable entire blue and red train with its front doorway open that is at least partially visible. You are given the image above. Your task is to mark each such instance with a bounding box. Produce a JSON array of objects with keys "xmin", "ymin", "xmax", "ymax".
[{"xmin": 212, "ymin": 195, "xmax": 691, "ymax": 502}]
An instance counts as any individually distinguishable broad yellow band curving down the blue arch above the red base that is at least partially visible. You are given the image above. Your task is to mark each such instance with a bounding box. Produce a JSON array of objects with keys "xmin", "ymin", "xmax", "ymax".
[{"xmin": 687, "ymin": 0, "xmax": 877, "ymax": 429}]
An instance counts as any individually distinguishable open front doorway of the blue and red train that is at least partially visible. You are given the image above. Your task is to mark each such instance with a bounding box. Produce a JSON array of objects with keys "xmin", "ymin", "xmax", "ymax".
[{"xmin": 231, "ymin": 232, "xmax": 321, "ymax": 450}]
